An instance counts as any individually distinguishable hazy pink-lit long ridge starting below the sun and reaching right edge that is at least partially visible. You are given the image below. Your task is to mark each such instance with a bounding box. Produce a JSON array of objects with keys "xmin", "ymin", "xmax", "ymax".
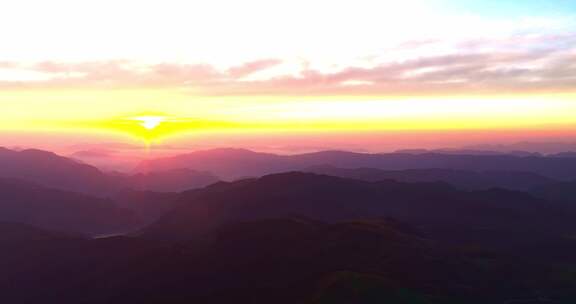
[{"xmin": 137, "ymin": 149, "xmax": 576, "ymax": 180}]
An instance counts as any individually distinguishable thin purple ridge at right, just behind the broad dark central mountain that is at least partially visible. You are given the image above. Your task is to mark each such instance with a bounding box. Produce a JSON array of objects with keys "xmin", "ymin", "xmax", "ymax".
[{"xmin": 302, "ymin": 166, "xmax": 555, "ymax": 190}]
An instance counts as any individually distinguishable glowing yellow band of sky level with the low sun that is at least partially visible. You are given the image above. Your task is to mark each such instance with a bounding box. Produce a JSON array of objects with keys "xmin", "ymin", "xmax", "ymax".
[{"xmin": 0, "ymin": 89, "xmax": 576, "ymax": 141}]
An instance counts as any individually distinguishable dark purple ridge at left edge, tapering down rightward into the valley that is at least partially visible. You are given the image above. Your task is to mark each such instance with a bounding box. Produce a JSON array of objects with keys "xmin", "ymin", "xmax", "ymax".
[{"xmin": 0, "ymin": 179, "xmax": 136, "ymax": 234}]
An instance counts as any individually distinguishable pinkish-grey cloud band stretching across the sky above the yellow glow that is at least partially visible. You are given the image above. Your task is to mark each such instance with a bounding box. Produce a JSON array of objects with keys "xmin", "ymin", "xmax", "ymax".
[{"xmin": 0, "ymin": 33, "xmax": 576, "ymax": 95}]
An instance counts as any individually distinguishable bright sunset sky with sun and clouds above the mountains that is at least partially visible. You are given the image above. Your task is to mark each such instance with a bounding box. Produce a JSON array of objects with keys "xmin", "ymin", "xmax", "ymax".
[{"xmin": 0, "ymin": 0, "xmax": 576, "ymax": 165}]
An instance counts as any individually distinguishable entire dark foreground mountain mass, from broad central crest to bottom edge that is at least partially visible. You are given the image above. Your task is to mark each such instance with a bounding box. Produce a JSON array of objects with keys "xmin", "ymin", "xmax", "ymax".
[{"xmin": 0, "ymin": 172, "xmax": 576, "ymax": 304}]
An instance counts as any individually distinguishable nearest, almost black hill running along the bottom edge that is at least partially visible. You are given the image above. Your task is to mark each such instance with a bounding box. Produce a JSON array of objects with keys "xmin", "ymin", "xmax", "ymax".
[{"xmin": 0, "ymin": 218, "xmax": 573, "ymax": 304}]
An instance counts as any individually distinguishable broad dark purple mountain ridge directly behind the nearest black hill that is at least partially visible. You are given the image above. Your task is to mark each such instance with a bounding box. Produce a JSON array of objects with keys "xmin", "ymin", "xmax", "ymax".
[{"xmin": 142, "ymin": 172, "xmax": 568, "ymax": 243}]
